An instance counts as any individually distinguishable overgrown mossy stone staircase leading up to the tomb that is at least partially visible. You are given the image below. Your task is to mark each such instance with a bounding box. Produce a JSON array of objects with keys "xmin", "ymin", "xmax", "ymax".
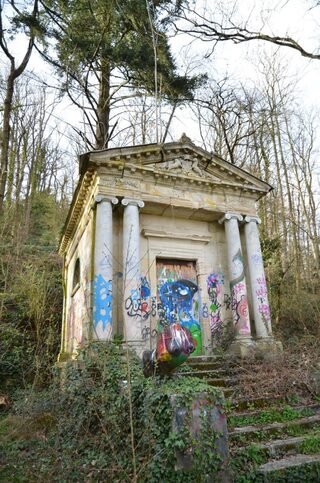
[{"xmin": 176, "ymin": 356, "xmax": 320, "ymax": 483}]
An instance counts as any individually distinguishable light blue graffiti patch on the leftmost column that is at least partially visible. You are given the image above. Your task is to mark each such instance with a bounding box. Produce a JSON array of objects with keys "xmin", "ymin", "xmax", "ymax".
[{"xmin": 93, "ymin": 275, "xmax": 112, "ymax": 330}]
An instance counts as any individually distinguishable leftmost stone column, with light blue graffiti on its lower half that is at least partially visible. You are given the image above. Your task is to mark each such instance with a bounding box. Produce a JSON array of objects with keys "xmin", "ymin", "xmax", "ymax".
[{"xmin": 93, "ymin": 196, "xmax": 118, "ymax": 340}]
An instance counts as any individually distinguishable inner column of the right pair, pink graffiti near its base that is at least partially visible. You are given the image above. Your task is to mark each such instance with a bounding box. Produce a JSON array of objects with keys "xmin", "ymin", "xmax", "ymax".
[{"xmin": 219, "ymin": 213, "xmax": 252, "ymax": 355}]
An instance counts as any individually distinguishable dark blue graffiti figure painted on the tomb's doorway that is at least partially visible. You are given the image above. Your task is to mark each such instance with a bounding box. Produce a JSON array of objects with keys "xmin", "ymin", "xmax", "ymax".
[{"xmin": 159, "ymin": 279, "xmax": 199, "ymax": 327}]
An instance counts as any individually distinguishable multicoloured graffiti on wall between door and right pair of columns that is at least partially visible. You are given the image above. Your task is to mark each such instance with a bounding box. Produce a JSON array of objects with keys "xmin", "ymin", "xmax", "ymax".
[{"xmin": 207, "ymin": 272, "xmax": 224, "ymax": 335}]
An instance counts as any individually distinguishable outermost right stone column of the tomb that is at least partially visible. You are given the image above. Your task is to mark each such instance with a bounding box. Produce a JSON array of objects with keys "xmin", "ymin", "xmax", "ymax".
[{"xmin": 244, "ymin": 216, "xmax": 272, "ymax": 338}]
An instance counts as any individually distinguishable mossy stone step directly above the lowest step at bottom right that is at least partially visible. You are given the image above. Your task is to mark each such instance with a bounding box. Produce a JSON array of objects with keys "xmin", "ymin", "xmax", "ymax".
[{"xmin": 229, "ymin": 413, "xmax": 320, "ymax": 443}]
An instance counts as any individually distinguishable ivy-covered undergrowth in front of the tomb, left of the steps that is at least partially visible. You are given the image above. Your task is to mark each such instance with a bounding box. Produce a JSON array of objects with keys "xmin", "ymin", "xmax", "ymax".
[{"xmin": 0, "ymin": 343, "xmax": 225, "ymax": 482}]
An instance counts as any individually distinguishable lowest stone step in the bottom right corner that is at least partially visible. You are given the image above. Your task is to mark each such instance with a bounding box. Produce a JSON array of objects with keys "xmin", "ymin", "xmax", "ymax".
[{"xmin": 258, "ymin": 453, "xmax": 320, "ymax": 483}]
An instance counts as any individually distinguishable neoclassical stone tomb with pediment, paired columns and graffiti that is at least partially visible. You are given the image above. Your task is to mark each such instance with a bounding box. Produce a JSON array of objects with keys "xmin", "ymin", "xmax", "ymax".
[{"xmin": 59, "ymin": 136, "xmax": 275, "ymax": 361}]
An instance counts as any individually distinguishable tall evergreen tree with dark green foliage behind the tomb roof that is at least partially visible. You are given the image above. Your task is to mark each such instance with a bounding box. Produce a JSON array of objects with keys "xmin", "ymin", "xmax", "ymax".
[{"xmin": 44, "ymin": 0, "xmax": 204, "ymax": 149}]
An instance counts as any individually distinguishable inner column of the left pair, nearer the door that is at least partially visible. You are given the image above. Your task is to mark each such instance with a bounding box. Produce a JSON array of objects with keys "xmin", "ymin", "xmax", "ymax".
[{"xmin": 122, "ymin": 198, "xmax": 144, "ymax": 353}]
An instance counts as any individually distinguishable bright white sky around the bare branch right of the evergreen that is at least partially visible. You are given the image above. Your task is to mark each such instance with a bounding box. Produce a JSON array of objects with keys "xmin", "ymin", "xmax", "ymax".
[{"xmin": 172, "ymin": 0, "xmax": 320, "ymax": 143}]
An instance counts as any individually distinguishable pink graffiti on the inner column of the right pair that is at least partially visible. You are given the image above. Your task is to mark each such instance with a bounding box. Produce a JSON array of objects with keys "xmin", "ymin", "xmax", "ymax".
[{"xmin": 230, "ymin": 248, "xmax": 250, "ymax": 335}]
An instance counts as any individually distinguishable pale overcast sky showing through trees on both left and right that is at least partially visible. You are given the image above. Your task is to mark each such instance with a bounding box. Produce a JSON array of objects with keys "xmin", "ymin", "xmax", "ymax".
[{"xmin": 1, "ymin": 0, "xmax": 320, "ymax": 151}]
